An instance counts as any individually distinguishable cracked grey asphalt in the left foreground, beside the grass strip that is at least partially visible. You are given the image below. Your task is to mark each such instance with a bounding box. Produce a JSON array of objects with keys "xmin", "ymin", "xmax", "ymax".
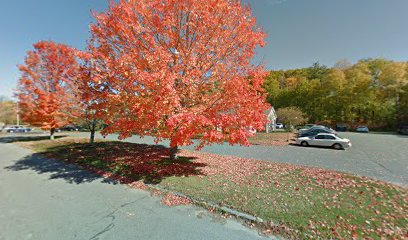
[{"xmin": 0, "ymin": 143, "xmax": 274, "ymax": 240}]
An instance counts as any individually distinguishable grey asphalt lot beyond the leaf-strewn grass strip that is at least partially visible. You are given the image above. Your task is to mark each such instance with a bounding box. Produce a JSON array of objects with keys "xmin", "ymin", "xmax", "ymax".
[{"xmin": 68, "ymin": 132, "xmax": 408, "ymax": 187}]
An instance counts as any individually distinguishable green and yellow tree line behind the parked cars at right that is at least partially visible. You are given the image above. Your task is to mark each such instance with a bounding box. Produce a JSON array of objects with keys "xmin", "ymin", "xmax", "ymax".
[{"xmin": 264, "ymin": 59, "xmax": 408, "ymax": 130}]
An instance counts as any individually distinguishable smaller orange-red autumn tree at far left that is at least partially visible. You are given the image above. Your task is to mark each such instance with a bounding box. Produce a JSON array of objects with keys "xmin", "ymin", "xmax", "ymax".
[{"xmin": 17, "ymin": 41, "xmax": 80, "ymax": 139}]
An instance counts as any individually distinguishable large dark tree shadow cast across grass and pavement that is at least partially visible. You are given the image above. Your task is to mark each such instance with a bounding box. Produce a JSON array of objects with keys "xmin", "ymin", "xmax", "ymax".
[{"xmin": 7, "ymin": 142, "xmax": 206, "ymax": 184}]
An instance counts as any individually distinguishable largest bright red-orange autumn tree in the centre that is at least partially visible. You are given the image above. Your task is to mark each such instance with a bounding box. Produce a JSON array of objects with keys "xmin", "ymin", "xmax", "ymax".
[{"xmin": 88, "ymin": 0, "xmax": 268, "ymax": 159}]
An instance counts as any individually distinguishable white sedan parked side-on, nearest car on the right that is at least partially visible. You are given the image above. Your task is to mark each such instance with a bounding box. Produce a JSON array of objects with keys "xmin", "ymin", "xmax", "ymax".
[{"xmin": 296, "ymin": 133, "xmax": 351, "ymax": 150}]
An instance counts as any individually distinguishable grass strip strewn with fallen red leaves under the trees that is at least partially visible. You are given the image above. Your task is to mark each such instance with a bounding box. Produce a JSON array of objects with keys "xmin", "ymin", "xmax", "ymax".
[{"xmin": 15, "ymin": 138, "xmax": 408, "ymax": 239}]
